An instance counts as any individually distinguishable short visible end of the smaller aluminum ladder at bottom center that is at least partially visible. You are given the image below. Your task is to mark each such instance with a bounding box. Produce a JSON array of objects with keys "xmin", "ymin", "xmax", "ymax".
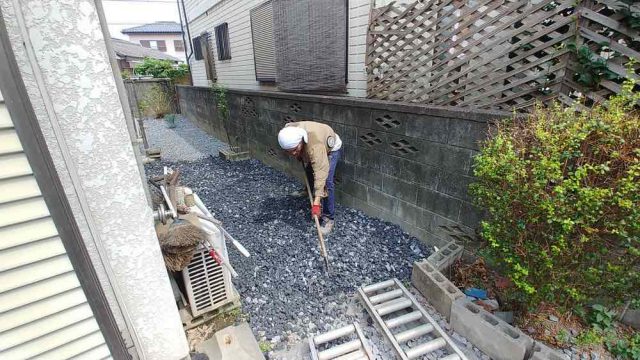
[{"xmin": 309, "ymin": 323, "xmax": 374, "ymax": 360}]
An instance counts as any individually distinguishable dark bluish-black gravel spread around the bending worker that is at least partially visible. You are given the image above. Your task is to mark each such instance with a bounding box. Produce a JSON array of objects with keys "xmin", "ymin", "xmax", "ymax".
[{"xmin": 146, "ymin": 157, "xmax": 432, "ymax": 339}]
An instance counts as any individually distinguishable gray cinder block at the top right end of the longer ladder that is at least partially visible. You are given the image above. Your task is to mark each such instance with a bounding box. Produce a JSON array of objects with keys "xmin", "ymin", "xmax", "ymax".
[{"xmin": 411, "ymin": 260, "xmax": 464, "ymax": 320}]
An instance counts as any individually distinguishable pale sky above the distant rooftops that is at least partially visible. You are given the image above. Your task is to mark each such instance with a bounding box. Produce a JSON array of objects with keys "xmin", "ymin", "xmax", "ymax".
[{"xmin": 102, "ymin": 0, "xmax": 180, "ymax": 40}]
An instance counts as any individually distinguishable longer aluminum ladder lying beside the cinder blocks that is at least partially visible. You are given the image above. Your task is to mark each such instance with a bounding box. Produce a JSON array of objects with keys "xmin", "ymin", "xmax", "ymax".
[{"xmin": 358, "ymin": 279, "xmax": 468, "ymax": 360}]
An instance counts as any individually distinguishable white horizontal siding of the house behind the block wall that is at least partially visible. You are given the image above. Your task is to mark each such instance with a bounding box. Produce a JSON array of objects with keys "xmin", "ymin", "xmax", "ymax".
[{"xmin": 184, "ymin": 0, "xmax": 370, "ymax": 97}]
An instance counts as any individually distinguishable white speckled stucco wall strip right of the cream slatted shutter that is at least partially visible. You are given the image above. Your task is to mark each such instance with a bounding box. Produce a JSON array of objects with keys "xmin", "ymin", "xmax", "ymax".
[{"xmin": 0, "ymin": 0, "xmax": 188, "ymax": 360}]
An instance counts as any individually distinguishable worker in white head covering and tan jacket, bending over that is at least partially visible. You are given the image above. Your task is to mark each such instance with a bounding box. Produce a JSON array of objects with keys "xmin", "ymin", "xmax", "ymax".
[{"xmin": 278, "ymin": 121, "xmax": 342, "ymax": 235}]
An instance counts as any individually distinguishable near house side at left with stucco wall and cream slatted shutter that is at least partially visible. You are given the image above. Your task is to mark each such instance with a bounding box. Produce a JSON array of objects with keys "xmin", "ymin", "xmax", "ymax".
[{"xmin": 0, "ymin": 0, "xmax": 189, "ymax": 360}]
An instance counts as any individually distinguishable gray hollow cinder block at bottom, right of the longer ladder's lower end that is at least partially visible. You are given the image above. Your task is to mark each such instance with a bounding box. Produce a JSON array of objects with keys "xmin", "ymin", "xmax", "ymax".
[{"xmin": 451, "ymin": 298, "xmax": 533, "ymax": 360}]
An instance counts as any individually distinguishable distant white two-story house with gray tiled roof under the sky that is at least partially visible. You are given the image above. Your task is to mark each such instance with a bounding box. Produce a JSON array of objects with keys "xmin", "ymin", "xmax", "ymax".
[{"xmin": 122, "ymin": 21, "xmax": 185, "ymax": 61}]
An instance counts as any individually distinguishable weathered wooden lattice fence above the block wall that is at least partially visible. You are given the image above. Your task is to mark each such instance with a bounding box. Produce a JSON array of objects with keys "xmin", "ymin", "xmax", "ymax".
[{"xmin": 366, "ymin": 0, "xmax": 640, "ymax": 110}]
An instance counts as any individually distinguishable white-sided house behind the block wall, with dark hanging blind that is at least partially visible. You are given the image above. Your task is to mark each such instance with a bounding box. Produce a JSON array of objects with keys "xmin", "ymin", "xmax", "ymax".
[{"xmin": 180, "ymin": 0, "xmax": 370, "ymax": 97}]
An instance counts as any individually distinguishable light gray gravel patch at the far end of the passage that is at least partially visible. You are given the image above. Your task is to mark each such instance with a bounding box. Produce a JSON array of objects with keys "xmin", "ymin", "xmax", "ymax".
[{"xmin": 144, "ymin": 115, "xmax": 227, "ymax": 161}]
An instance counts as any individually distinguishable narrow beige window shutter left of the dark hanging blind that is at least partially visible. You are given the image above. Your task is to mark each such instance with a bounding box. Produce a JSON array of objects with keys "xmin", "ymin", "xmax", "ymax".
[{"xmin": 251, "ymin": 1, "xmax": 276, "ymax": 81}]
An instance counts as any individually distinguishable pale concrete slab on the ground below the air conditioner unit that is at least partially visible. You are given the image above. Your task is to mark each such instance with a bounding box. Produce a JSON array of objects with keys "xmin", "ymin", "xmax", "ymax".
[{"xmin": 196, "ymin": 322, "xmax": 264, "ymax": 360}]
